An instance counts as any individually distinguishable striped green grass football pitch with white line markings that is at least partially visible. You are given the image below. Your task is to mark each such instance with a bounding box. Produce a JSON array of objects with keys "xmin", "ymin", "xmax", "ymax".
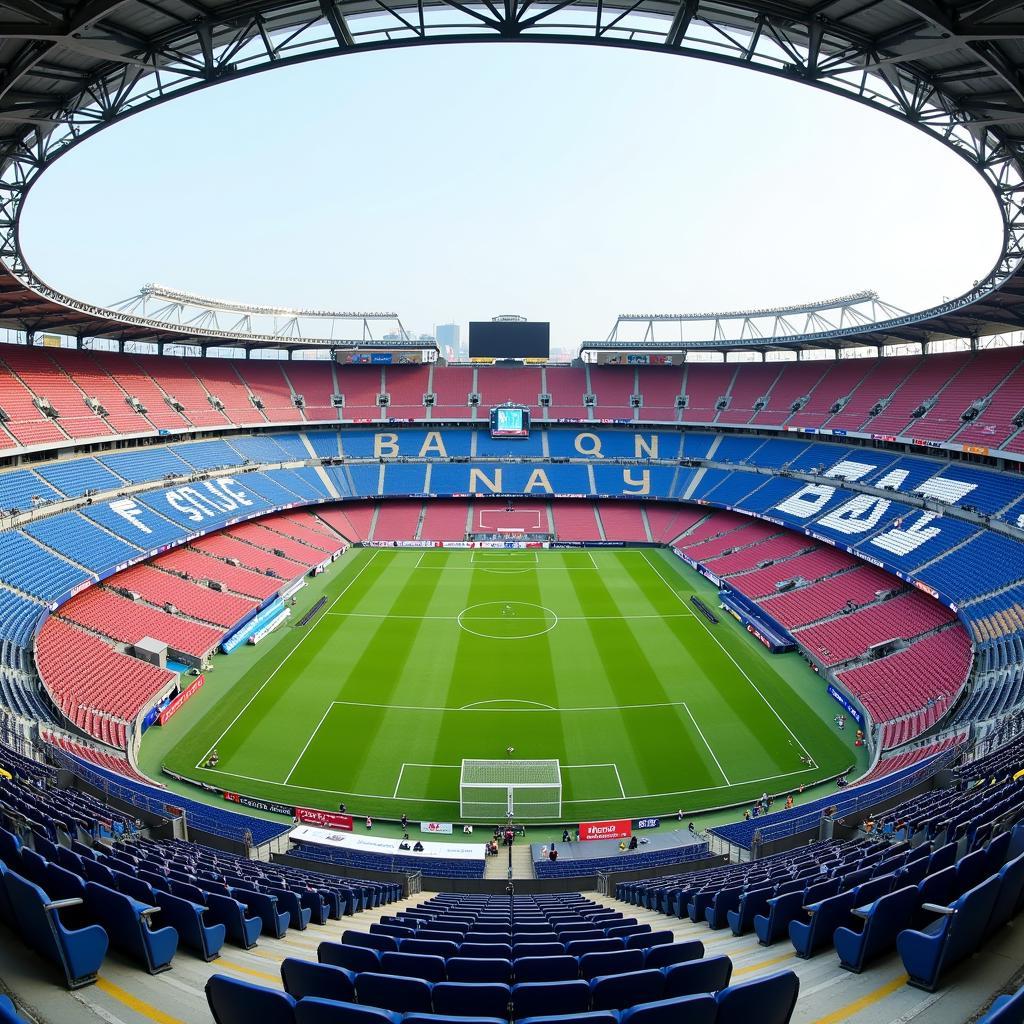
[{"xmin": 149, "ymin": 549, "xmax": 856, "ymax": 821}]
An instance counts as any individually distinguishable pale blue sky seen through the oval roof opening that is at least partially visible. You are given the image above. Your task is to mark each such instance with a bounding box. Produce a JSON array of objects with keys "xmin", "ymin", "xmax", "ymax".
[{"xmin": 23, "ymin": 43, "xmax": 999, "ymax": 348}]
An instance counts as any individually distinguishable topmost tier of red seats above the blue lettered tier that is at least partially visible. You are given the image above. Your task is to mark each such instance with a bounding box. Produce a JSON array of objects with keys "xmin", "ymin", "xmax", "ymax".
[{"xmin": 0, "ymin": 345, "xmax": 1024, "ymax": 452}]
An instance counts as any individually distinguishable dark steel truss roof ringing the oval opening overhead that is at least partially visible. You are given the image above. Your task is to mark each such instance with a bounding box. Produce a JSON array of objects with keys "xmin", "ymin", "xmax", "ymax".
[{"xmin": 0, "ymin": 0, "xmax": 1024, "ymax": 347}]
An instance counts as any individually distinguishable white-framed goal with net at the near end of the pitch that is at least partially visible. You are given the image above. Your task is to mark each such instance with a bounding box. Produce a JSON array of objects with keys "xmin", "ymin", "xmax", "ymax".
[{"xmin": 459, "ymin": 759, "xmax": 562, "ymax": 823}]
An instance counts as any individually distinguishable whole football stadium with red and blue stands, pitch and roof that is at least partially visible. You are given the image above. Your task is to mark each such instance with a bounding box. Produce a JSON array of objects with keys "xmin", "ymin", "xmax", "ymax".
[{"xmin": 0, "ymin": 6, "xmax": 1024, "ymax": 1024}]
